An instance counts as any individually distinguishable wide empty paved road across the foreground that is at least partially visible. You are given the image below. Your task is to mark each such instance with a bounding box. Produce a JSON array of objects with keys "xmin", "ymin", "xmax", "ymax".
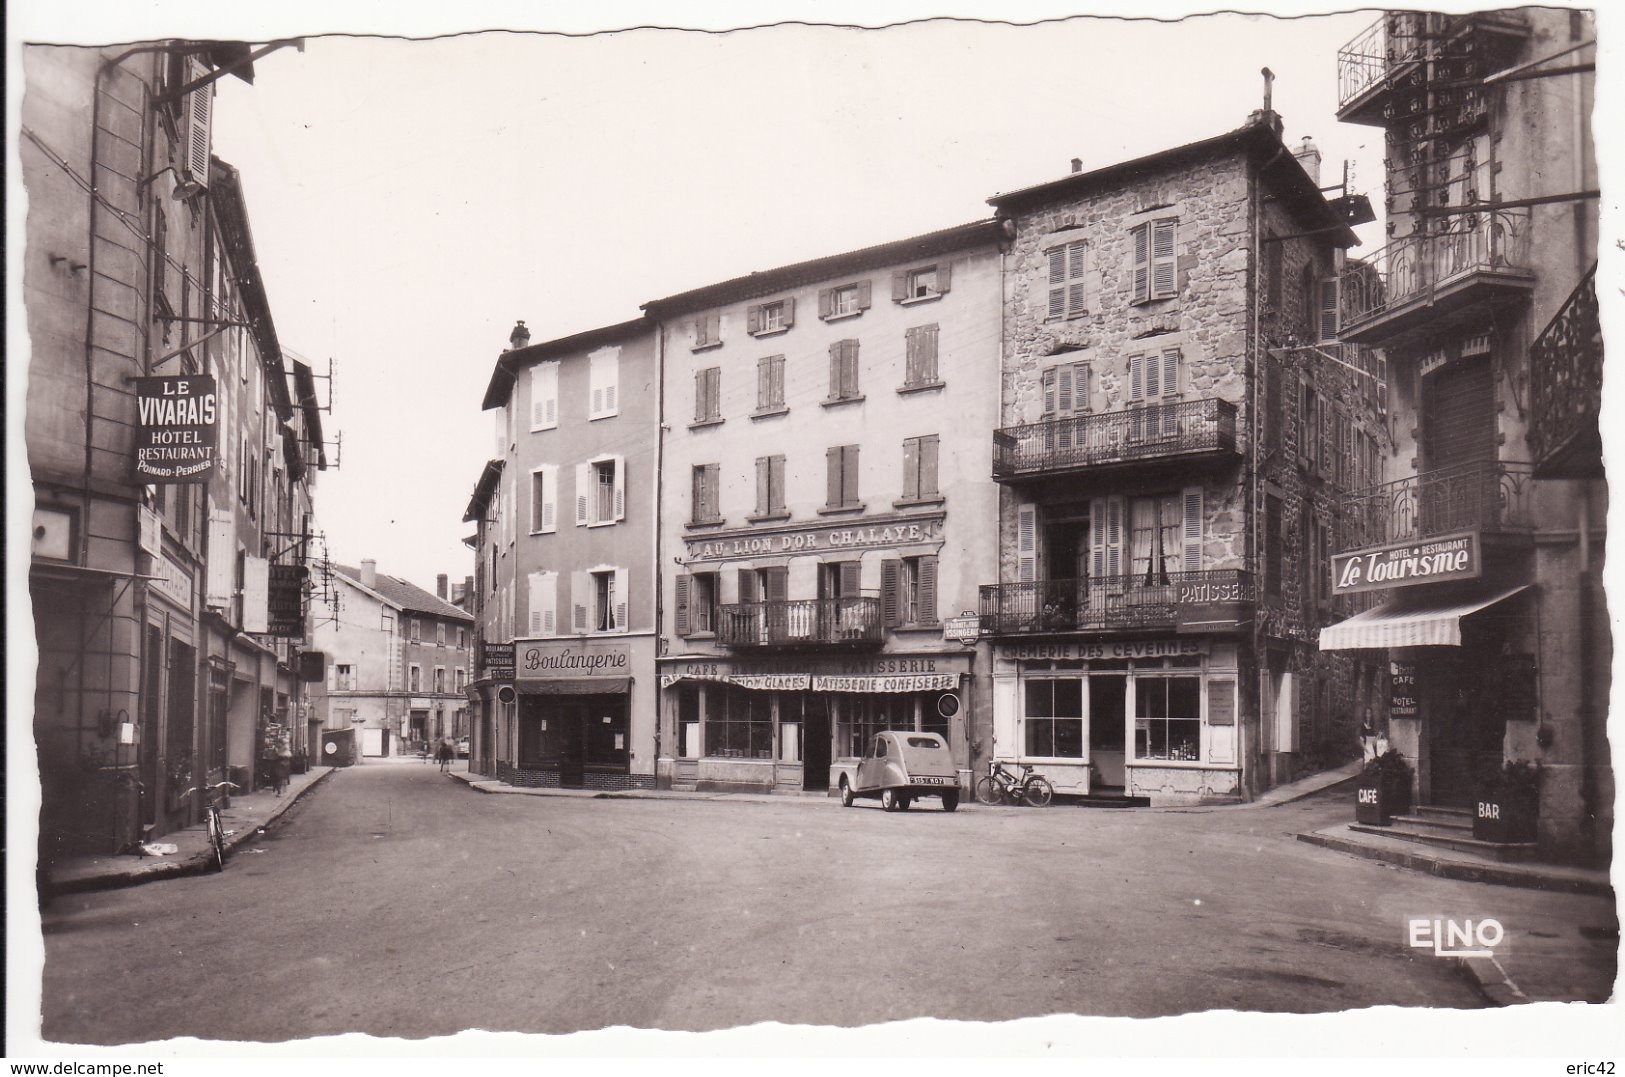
[{"xmin": 34, "ymin": 765, "xmax": 1607, "ymax": 1043}]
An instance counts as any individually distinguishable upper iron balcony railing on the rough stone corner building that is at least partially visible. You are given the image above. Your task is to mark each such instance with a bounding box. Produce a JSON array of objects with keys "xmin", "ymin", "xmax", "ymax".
[{"xmin": 993, "ymin": 398, "xmax": 1235, "ymax": 479}]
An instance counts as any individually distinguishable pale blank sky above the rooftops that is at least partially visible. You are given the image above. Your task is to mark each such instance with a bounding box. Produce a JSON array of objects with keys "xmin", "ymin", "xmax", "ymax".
[{"xmin": 15, "ymin": 5, "xmax": 1410, "ymax": 588}]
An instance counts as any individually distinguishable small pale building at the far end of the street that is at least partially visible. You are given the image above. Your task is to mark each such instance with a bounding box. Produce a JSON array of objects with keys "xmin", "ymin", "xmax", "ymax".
[{"xmin": 314, "ymin": 560, "xmax": 475, "ymax": 757}]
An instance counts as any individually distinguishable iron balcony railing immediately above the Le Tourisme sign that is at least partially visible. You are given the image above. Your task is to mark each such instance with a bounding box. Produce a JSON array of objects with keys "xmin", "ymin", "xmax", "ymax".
[{"xmin": 1337, "ymin": 460, "xmax": 1534, "ymax": 552}]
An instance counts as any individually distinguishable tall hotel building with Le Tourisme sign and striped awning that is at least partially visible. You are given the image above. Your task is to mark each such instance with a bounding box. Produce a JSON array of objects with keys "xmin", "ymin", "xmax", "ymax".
[{"xmin": 1321, "ymin": 8, "xmax": 1614, "ymax": 859}]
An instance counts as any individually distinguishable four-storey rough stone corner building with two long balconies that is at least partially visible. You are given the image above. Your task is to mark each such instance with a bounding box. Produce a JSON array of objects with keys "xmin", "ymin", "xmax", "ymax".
[{"xmin": 978, "ymin": 110, "xmax": 1386, "ymax": 802}]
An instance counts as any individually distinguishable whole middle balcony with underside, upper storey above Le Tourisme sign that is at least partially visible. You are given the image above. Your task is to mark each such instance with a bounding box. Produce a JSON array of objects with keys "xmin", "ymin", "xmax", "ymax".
[{"xmin": 1339, "ymin": 205, "xmax": 1534, "ymax": 346}]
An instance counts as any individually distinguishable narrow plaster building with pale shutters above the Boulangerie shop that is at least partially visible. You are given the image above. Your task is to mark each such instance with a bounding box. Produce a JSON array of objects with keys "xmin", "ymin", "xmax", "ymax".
[{"xmin": 465, "ymin": 318, "xmax": 660, "ymax": 789}]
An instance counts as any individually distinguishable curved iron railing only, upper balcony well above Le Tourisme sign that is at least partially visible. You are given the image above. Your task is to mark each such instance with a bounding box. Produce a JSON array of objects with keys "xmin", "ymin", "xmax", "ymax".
[{"xmin": 1339, "ymin": 205, "xmax": 1531, "ymax": 330}]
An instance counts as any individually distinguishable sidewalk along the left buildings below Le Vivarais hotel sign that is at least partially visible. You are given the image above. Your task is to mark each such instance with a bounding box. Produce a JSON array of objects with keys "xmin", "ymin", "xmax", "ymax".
[{"xmin": 50, "ymin": 767, "xmax": 336, "ymax": 893}]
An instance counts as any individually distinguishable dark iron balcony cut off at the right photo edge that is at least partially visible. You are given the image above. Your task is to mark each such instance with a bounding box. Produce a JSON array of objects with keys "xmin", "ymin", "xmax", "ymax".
[{"xmin": 1529, "ymin": 266, "xmax": 1602, "ymax": 479}]
